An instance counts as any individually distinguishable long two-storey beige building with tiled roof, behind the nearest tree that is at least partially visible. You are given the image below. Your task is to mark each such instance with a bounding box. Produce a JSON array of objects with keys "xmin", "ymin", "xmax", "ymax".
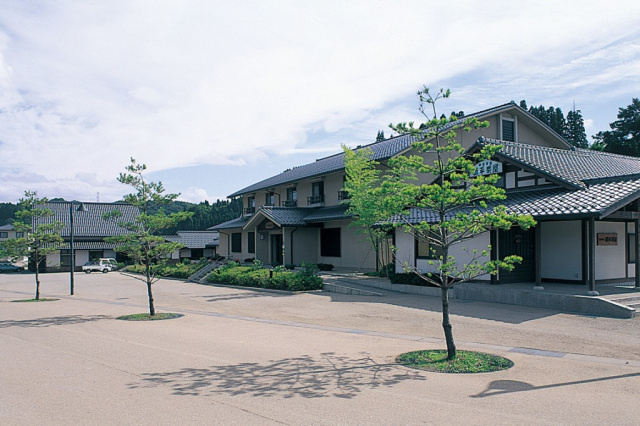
[{"xmin": 211, "ymin": 103, "xmax": 572, "ymax": 270}]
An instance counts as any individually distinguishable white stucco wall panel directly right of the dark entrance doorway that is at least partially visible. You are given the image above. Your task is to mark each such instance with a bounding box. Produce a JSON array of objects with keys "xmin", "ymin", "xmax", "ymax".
[{"xmin": 538, "ymin": 220, "xmax": 582, "ymax": 280}]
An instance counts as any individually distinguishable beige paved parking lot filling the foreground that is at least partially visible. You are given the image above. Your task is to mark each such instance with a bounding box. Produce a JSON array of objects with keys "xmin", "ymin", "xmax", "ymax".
[{"xmin": 0, "ymin": 273, "xmax": 640, "ymax": 425}]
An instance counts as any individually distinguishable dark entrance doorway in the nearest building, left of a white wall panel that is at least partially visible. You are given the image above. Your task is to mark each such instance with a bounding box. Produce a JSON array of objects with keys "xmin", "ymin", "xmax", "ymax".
[{"xmin": 498, "ymin": 228, "xmax": 536, "ymax": 284}]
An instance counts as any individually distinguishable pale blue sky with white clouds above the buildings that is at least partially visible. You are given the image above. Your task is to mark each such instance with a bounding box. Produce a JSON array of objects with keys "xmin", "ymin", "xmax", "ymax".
[{"xmin": 0, "ymin": 0, "xmax": 640, "ymax": 202}]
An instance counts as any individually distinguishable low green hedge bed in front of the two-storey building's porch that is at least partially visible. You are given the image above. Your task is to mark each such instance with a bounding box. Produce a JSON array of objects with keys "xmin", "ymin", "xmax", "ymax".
[{"xmin": 206, "ymin": 264, "xmax": 322, "ymax": 291}]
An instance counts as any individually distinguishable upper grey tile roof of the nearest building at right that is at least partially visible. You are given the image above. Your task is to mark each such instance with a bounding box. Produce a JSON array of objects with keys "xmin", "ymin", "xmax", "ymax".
[{"xmin": 471, "ymin": 138, "xmax": 640, "ymax": 188}]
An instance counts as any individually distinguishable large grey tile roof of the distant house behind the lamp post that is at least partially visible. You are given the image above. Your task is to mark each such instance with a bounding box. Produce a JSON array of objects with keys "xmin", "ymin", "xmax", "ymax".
[{"xmin": 37, "ymin": 201, "xmax": 140, "ymax": 238}]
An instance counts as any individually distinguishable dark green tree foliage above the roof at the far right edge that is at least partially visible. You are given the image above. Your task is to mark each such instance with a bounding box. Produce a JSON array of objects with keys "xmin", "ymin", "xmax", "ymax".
[{"xmin": 593, "ymin": 98, "xmax": 640, "ymax": 157}]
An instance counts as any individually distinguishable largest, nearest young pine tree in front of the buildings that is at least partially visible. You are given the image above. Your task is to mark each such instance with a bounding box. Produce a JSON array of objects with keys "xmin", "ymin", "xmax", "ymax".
[{"xmin": 346, "ymin": 87, "xmax": 535, "ymax": 359}]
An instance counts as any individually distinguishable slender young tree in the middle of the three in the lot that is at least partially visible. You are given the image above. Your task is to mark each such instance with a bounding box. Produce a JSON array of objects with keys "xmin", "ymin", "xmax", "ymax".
[{"xmin": 104, "ymin": 158, "xmax": 193, "ymax": 316}]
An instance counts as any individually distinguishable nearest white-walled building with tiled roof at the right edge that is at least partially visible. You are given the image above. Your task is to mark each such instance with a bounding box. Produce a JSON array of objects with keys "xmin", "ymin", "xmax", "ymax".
[{"xmin": 391, "ymin": 138, "xmax": 640, "ymax": 294}]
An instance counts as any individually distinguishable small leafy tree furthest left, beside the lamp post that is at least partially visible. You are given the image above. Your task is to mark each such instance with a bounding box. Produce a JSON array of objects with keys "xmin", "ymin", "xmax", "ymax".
[{"xmin": 3, "ymin": 191, "xmax": 64, "ymax": 300}]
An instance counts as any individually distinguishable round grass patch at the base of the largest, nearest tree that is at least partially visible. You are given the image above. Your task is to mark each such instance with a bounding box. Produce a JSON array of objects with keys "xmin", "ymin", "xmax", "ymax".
[{"xmin": 396, "ymin": 349, "xmax": 513, "ymax": 373}]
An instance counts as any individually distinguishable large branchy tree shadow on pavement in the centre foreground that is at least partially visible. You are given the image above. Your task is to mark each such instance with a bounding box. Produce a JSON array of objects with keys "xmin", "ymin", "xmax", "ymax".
[{"xmin": 129, "ymin": 352, "xmax": 426, "ymax": 399}]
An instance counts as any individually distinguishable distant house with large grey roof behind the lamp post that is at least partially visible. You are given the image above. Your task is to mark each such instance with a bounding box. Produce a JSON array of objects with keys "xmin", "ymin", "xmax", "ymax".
[{"xmin": 37, "ymin": 201, "xmax": 140, "ymax": 271}]
